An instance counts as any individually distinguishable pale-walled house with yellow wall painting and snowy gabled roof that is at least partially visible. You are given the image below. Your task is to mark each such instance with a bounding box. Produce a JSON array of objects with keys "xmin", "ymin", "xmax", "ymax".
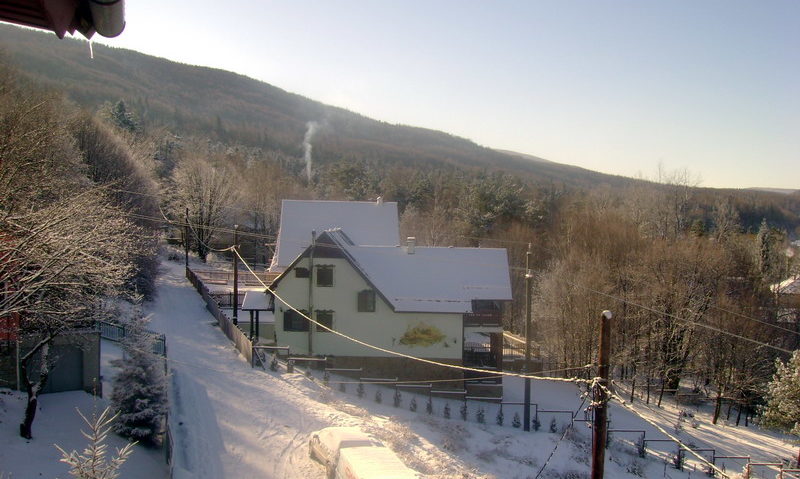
[{"xmin": 272, "ymin": 229, "xmax": 511, "ymax": 380}]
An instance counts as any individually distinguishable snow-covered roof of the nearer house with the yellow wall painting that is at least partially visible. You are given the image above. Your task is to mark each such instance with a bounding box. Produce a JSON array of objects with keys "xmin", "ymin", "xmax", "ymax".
[{"xmin": 325, "ymin": 230, "xmax": 512, "ymax": 313}]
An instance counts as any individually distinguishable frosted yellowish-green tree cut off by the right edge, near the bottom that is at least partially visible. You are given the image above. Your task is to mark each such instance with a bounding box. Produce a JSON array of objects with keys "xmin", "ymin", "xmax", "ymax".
[{"xmin": 762, "ymin": 351, "xmax": 800, "ymax": 435}]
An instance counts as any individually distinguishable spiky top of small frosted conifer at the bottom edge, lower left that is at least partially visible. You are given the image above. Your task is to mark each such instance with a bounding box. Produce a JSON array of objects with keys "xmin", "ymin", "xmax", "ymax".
[{"xmin": 56, "ymin": 408, "xmax": 134, "ymax": 479}]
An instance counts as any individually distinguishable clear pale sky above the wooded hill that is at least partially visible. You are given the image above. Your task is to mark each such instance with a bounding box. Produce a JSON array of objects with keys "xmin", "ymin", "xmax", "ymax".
[{"xmin": 90, "ymin": 0, "xmax": 800, "ymax": 189}]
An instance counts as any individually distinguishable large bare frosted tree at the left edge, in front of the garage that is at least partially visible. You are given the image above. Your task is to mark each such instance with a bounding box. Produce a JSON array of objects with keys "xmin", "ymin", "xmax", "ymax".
[{"xmin": 0, "ymin": 64, "xmax": 138, "ymax": 437}]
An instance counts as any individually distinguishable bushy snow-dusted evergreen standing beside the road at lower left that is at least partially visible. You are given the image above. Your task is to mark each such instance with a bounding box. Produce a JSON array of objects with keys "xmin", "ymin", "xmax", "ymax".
[{"xmin": 111, "ymin": 308, "xmax": 167, "ymax": 443}]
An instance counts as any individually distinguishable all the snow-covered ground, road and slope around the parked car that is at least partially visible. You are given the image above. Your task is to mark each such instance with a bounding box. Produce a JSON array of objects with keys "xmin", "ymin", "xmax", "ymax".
[{"xmin": 0, "ymin": 253, "xmax": 796, "ymax": 479}]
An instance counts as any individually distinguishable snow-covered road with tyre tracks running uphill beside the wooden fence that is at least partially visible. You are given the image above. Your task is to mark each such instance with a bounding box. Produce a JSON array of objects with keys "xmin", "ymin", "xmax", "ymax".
[{"xmin": 148, "ymin": 262, "xmax": 338, "ymax": 479}]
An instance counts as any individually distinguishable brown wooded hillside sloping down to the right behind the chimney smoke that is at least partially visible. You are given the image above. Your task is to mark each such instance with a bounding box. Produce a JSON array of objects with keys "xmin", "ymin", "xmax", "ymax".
[{"xmin": 0, "ymin": 25, "xmax": 634, "ymax": 187}]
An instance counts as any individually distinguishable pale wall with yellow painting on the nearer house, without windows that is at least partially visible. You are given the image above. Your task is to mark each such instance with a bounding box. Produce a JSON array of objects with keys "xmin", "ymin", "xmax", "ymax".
[{"xmin": 275, "ymin": 258, "xmax": 463, "ymax": 360}]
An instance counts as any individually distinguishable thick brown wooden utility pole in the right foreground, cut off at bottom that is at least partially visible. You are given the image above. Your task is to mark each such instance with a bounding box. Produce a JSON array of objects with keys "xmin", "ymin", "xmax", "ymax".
[{"xmin": 592, "ymin": 310, "xmax": 613, "ymax": 479}]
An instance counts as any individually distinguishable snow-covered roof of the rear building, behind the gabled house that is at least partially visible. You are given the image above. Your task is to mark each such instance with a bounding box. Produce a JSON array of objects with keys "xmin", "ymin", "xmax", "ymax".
[{"xmin": 270, "ymin": 200, "xmax": 400, "ymax": 272}]
